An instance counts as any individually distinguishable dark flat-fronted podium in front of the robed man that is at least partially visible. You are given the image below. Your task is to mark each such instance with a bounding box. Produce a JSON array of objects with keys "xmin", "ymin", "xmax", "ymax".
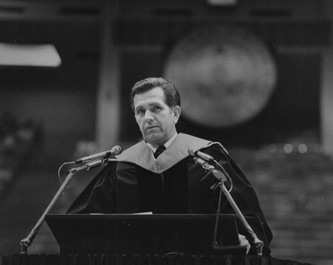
[{"xmin": 45, "ymin": 214, "xmax": 246, "ymax": 255}]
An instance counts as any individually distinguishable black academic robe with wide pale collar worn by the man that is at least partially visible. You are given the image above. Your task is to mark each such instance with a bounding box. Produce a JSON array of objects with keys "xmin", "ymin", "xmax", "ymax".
[{"xmin": 68, "ymin": 134, "xmax": 272, "ymax": 254}]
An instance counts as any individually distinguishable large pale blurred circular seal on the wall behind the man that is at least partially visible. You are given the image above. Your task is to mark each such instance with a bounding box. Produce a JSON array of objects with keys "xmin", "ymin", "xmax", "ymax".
[{"xmin": 164, "ymin": 26, "xmax": 277, "ymax": 128}]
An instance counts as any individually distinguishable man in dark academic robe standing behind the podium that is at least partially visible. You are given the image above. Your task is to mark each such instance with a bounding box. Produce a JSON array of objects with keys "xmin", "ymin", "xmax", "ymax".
[{"xmin": 68, "ymin": 78, "xmax": 272, "ymax": 254}]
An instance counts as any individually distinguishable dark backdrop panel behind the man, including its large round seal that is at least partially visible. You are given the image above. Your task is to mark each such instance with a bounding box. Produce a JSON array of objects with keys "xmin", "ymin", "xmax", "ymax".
[{"xmin": 119, "ymin": 24, "xmax": 321, "ymax": 145}]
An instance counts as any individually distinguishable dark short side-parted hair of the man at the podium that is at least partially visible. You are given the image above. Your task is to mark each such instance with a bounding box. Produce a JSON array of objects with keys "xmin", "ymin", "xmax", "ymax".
[{"xmin": 130, "ymin": 77, "xmax": 180, "ymax": 111}]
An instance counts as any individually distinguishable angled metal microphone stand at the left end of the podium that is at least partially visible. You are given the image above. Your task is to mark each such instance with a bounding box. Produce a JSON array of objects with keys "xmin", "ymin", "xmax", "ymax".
[{"xmin": 20, "ymin": 159, "xmax": 108, "ymax": 254}]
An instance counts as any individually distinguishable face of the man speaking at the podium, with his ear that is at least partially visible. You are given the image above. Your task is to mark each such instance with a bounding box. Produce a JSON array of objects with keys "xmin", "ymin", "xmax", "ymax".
[{"xmin": 133, "ymin": 87, "xmax": 181, "ymax": 146}]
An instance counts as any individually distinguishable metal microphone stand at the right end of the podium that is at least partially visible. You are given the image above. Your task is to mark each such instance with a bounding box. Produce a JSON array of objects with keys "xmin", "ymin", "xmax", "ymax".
[{"xmin": 212, "ymin": 160, "xmax": 264, "ymax": 256}]
